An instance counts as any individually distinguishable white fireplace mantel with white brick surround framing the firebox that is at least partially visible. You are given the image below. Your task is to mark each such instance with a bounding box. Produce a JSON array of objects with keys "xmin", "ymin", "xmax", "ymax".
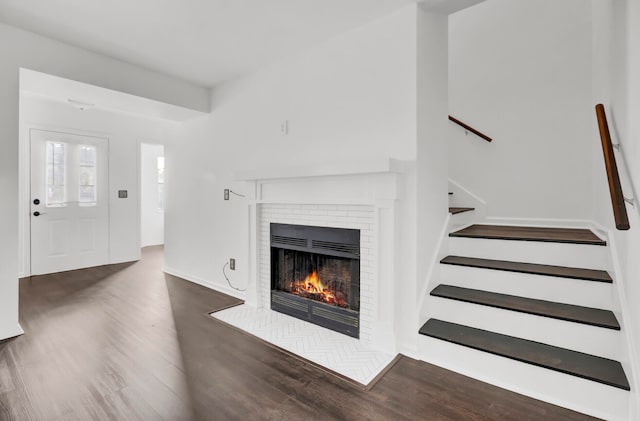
[{"xmin": 237, "ymin": 159, "xmax": 411, "ymax": 353}]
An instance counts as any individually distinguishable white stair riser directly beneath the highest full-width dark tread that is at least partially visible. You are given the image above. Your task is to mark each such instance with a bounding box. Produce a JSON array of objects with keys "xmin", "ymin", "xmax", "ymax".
[{"xmin": 449, "ymin": 237, "xmax": 609, "ymax": 270}]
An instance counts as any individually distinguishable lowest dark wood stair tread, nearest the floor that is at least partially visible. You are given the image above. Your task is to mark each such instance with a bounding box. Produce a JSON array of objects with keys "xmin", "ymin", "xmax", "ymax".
[{"xmin": 420, "ymin": 319, "xmax": 631, "ymax": 390}]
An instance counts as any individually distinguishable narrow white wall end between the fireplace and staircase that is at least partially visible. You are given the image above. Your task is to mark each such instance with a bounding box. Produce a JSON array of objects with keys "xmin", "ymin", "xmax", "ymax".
[{"xmin": 412, "ymin": 7, "xmax": 448, "ymax": 352}]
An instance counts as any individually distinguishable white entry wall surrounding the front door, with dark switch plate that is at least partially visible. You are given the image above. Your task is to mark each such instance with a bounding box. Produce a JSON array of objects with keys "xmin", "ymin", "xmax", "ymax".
[{"xmin": 19, "ymin": 95, "xmax": 179, "ymax": 276}]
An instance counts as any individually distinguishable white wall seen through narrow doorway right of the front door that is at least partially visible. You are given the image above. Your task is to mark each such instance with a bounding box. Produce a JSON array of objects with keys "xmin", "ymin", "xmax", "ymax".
[{"xmin": 140, "ymin": 143, "xmax": 164, "ymax": 247}]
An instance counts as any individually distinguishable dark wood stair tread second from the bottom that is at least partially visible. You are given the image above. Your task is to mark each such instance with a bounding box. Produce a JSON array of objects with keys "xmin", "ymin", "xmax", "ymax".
[{"xmin": 431, "ymin": 285, "xmax": 620, "ymax": 330}]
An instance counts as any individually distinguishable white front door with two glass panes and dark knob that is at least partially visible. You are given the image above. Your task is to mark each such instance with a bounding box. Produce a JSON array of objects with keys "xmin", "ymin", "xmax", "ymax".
[{"xmin": 31, "ymin": 130, "xmax": 109, "ymax": 275}]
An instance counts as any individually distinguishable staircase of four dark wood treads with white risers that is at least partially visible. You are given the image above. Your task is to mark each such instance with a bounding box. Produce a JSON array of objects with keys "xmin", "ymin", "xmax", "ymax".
[{"xmin": 419, "ymin": 225, "xmax": 630, "ymax": 420}]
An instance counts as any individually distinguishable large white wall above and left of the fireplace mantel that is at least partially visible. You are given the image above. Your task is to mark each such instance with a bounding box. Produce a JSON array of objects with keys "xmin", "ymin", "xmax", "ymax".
[{"xmin": 165, "ymin": 6, "xmax": 416, "ymax": 306}]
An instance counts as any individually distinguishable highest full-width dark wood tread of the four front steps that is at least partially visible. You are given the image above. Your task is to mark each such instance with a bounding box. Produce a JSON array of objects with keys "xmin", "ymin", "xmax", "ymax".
[{"xmin": 449, "ymin": 225, "xmax": 607, "ymax": 246}]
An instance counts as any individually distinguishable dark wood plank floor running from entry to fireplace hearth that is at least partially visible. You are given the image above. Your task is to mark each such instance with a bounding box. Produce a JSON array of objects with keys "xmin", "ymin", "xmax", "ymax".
[{"xmin": 0, "ymin": 247, "xmax": 588, "ymax": 421}]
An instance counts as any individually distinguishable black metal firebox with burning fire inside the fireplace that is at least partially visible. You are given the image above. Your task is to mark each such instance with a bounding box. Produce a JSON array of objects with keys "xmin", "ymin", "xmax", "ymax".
[{"xmin": 271, "ymin": 223, "xmax": 360, "ymax": 338}]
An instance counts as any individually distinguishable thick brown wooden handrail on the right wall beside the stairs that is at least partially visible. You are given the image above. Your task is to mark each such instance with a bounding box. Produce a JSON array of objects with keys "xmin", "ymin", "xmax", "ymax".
[{"xmin": 596, "ymin": 104, "xmax": 629, "ymax": 230}]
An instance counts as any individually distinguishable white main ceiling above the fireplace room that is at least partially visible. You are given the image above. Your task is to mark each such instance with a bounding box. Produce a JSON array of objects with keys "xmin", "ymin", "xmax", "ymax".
[{"xmin": 0, "ymin": 0, "xmax": 415, "ymax": 87}]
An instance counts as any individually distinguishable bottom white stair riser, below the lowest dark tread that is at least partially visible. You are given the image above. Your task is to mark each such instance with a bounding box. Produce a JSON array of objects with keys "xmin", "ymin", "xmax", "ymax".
[{"xmin": 418, "ymin": 335, "xmax": 630, "ymax": 421}]
